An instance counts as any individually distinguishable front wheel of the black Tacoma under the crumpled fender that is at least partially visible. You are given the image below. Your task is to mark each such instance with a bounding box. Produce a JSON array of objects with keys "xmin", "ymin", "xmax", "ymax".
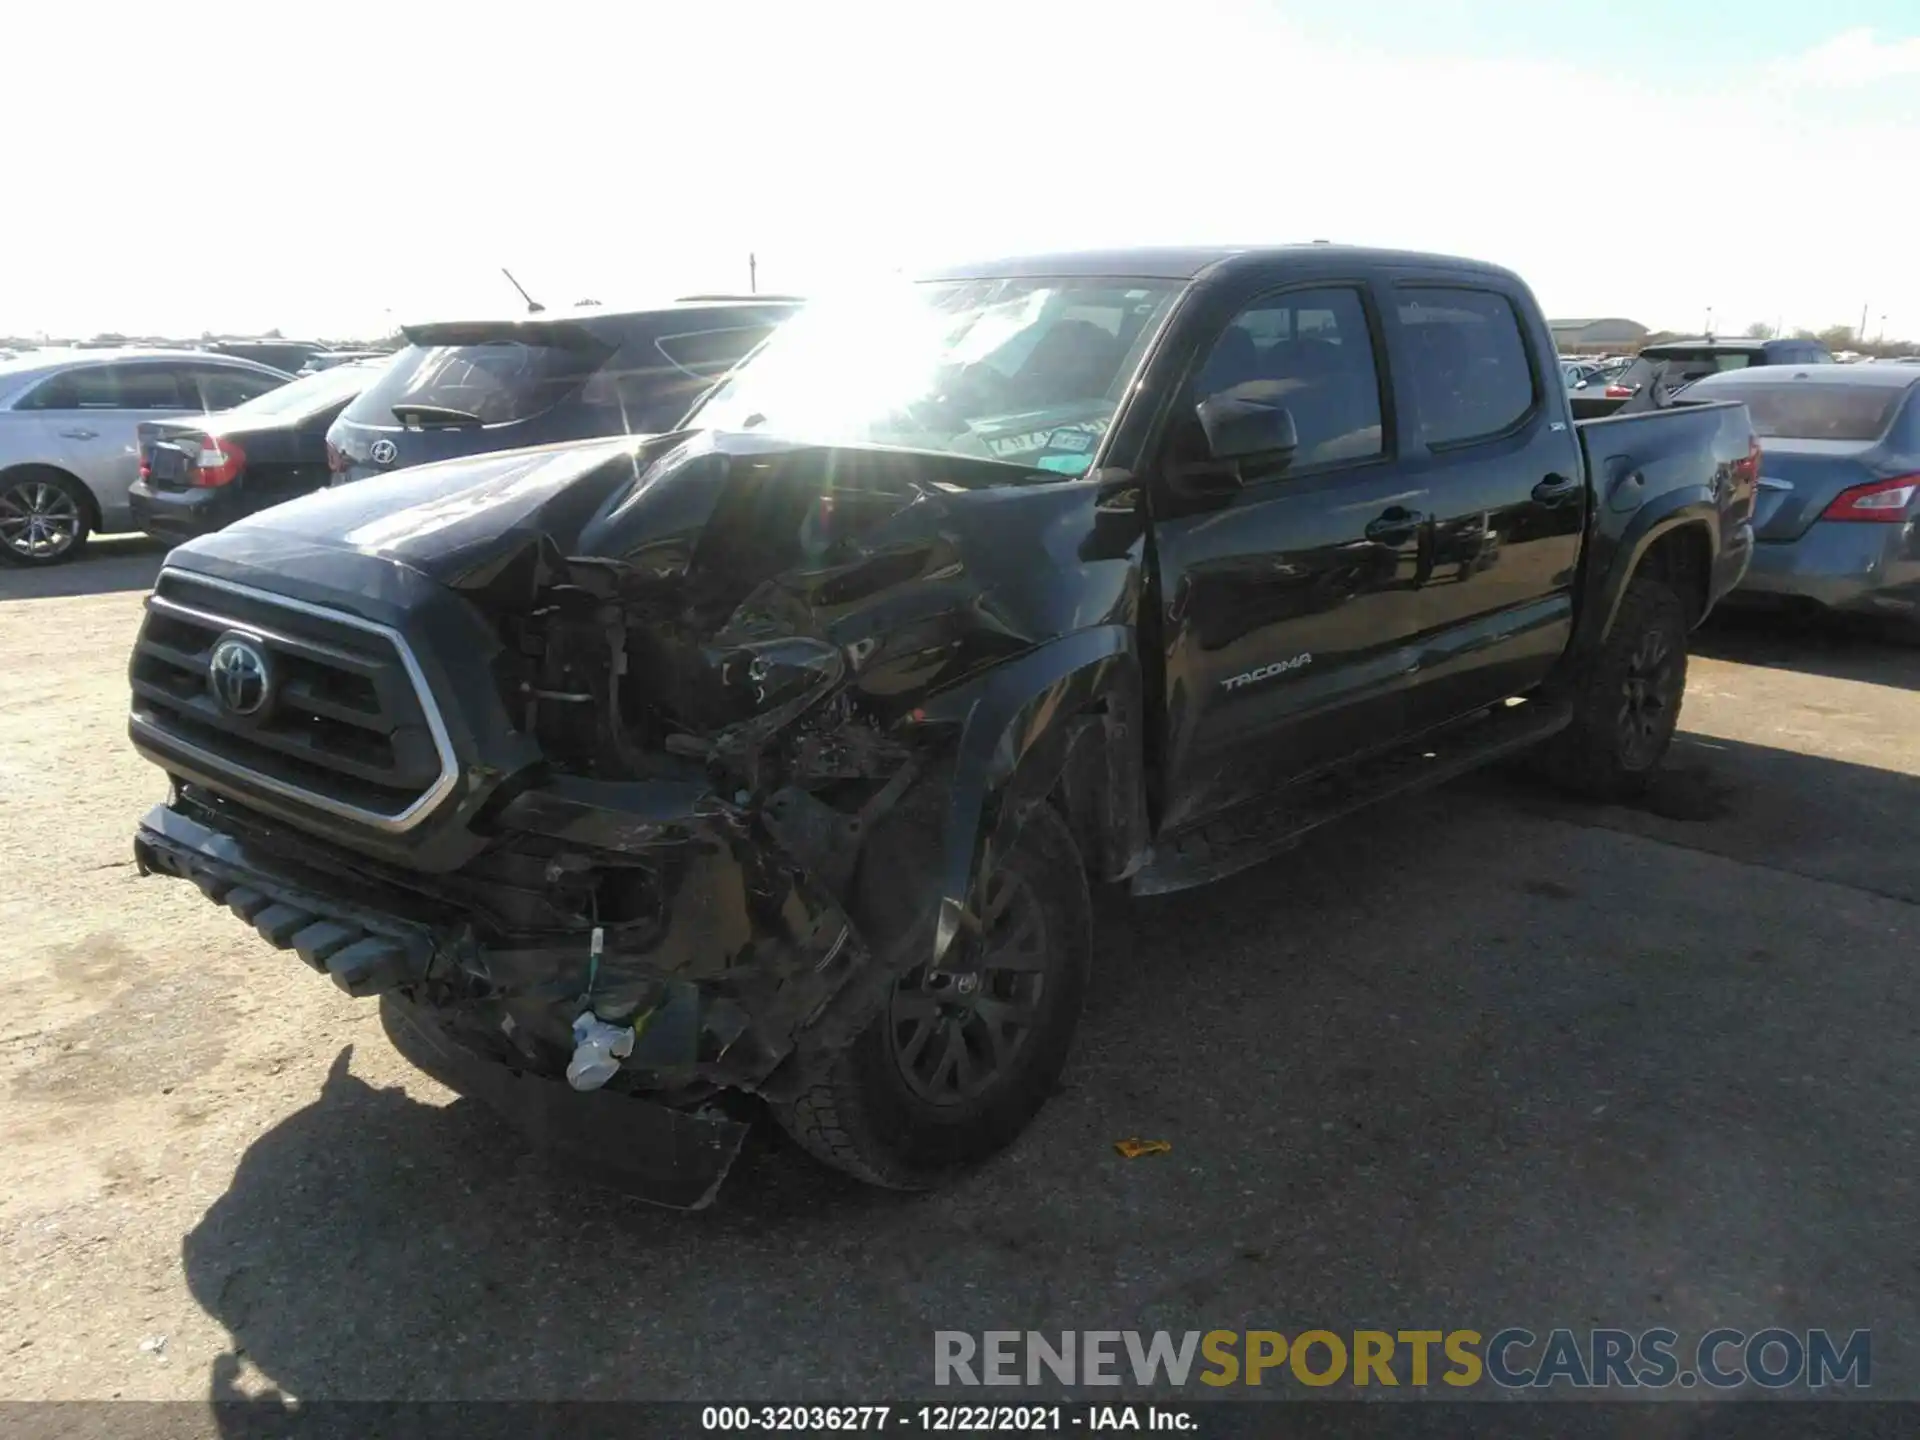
[{"xmin": 772, "ymin": 787, "xmax": 1092, "ymax": 1190}]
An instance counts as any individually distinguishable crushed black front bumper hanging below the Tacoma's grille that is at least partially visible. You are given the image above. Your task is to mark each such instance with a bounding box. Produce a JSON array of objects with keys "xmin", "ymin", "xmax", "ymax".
[{"xmin": 134, "ymin": 793, "xmax": 881, "ymax": 1208}]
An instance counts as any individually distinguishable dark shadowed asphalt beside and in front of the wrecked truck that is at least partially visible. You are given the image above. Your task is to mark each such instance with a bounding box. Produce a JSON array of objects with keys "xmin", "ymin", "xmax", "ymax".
[{"xmin": 184, "ymin": 741, "xmax": 1920, "ymax": 1400}]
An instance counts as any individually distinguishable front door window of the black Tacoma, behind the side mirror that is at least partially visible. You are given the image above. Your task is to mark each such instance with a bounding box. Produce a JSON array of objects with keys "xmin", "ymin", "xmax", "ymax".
[{"xmin": 1194, "ymin": 286, "xmax": 1382, "ymax": 468}]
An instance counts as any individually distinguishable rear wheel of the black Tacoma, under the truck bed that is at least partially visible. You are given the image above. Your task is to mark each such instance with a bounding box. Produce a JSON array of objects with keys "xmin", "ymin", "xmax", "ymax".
[{"xmin": 1540, "ymin": 578, "xmax": 1688, "ymax": 801}]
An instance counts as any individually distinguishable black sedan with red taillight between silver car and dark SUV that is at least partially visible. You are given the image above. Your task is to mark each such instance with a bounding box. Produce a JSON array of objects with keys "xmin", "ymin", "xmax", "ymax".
[{"xmin": 127, "ymin": 361, "xmax": 384, "ymax": 540}]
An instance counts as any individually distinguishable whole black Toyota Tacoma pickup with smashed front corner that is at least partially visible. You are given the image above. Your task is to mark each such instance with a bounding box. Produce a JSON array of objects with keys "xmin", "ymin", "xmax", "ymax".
[{"xmin": 131, "ymin": 244, "xmax": 1759, "ymax": 1206}]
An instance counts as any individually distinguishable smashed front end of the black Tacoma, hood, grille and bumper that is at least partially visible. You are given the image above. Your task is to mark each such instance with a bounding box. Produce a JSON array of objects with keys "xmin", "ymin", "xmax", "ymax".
[{"xmin": 131, "ymin": 434, "xmax": 1146, "ymax": 1206}]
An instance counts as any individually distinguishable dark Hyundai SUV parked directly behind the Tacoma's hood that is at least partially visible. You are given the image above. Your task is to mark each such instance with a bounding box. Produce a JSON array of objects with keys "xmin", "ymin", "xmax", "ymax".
[{"xmin": 326, "ymin": 296, "xmax": 799, "ymax": 484}]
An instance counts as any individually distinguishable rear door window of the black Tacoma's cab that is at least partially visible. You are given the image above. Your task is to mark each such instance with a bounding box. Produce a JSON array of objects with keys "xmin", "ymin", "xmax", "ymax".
[{"xmin": 1400, "ymin": 286, "xmax": 1538, "ymax": 445}]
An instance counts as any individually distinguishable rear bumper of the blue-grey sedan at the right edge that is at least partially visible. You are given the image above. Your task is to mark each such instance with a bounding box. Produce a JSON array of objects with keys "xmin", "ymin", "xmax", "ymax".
[{"xmin": 1732, "ymin": 520, "xmax": 1920, "ymax": 616}]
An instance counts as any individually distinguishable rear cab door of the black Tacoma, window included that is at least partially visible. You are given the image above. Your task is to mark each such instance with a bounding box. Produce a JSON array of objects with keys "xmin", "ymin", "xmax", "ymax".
[{"xmin": 1386, "ymin": 278, "xmax": 1588, "ymax": 730}]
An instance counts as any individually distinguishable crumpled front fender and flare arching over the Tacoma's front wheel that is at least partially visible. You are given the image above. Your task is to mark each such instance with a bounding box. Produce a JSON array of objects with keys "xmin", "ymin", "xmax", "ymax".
[{"xmin": 924, "ymin": 624, "xmax": 1146, "ymax": 966}]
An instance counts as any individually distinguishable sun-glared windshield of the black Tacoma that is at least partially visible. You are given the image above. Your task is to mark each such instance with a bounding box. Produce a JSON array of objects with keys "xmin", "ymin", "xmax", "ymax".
[{"xmin": 687, "ymin": 278, "xmax": 1181, "ymax": 474}]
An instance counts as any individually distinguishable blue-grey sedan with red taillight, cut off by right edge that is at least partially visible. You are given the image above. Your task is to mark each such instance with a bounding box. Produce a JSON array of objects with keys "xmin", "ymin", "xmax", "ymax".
[{"xmin": 1688, "ymin": 365, "xmax": 1920, "ymax": 639}]
